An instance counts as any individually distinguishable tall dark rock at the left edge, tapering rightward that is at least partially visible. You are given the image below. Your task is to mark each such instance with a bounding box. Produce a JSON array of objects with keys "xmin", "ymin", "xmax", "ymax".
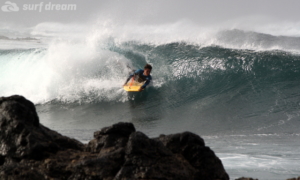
[{"xmin": 0, "ymin": 96, "xmax": 83, "ymax": 161}]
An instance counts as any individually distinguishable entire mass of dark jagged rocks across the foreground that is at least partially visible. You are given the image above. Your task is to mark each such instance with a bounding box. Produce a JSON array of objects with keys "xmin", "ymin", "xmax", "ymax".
[{"xmin": 0, "ymin": 96, "xmax": 229, "ymax": 180}]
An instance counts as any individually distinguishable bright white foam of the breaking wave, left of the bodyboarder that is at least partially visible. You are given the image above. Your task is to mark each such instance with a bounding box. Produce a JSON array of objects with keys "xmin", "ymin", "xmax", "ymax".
[{"xmin": 0, "ymin": 37, "xmax": 129, "ymax": 103}]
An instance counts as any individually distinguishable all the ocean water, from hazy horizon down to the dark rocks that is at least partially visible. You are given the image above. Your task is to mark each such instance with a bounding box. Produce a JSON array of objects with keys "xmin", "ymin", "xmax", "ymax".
[{"xmin": 0, "ymin": 23, "xmax": 300, "ymax": 180}]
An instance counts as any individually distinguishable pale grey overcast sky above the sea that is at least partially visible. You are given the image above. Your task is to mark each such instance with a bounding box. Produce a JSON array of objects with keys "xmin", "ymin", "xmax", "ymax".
[{"xmin": 0, "ymin": 0, "xmax": 300, "ymax": 27}]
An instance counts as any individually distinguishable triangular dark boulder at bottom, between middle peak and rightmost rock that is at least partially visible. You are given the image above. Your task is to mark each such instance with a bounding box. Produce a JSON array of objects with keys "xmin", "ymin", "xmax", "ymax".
[{"xmin": 116, "ymin": 132, "xmax": 195, "ymax": 180}]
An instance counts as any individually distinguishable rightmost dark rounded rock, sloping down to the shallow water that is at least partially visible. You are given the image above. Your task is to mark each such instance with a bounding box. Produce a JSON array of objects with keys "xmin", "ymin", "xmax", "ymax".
[{"xmin": 157, "ymin": 132, "xmax": 229, "ymax": 179}]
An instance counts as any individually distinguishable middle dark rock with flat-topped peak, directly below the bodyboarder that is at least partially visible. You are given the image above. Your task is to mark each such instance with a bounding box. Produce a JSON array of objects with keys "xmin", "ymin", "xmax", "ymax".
[{"xmin": 71, "ymin": 122, "xmax": 135, "ymax": 179}]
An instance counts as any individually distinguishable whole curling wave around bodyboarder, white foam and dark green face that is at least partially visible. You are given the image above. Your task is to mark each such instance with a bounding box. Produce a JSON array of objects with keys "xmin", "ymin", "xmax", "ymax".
[{"xmin": 0, "ymin": 30, "xmax": 300, "ymax": 134}]
